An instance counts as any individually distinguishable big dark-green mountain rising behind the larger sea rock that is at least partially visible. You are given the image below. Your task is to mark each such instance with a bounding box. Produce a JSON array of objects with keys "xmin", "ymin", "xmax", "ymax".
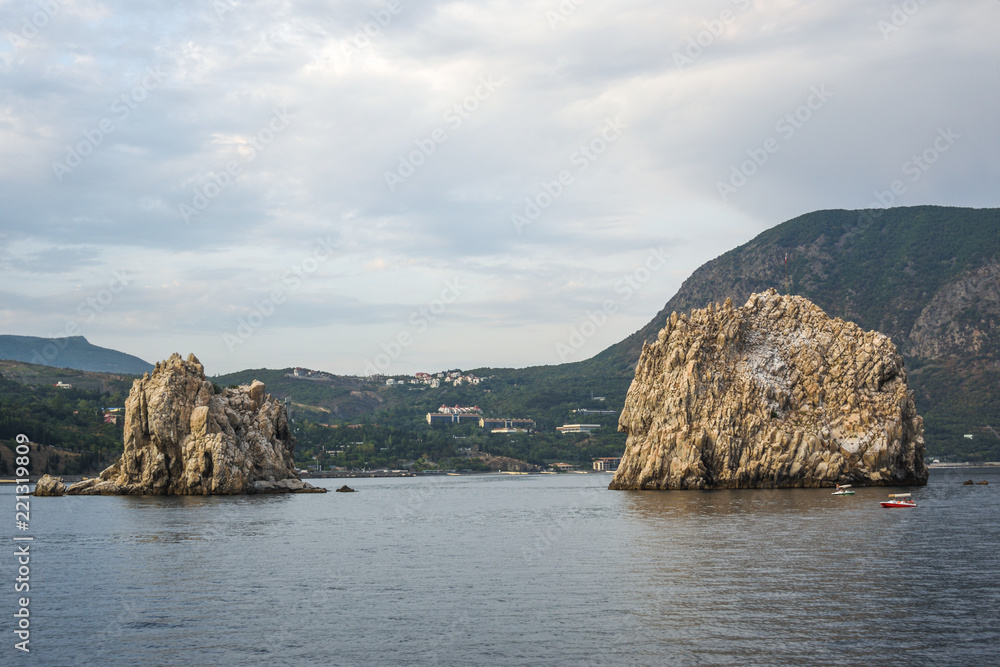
[{"xmin": 583, "ymin": 206, "xmax": 1000, "ymax": 460}]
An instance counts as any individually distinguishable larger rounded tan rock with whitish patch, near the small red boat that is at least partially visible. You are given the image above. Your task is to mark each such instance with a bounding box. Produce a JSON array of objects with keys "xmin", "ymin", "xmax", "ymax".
[{"xmin": 610, "ymin": 290, "xmax": 927, "ymax": 489}]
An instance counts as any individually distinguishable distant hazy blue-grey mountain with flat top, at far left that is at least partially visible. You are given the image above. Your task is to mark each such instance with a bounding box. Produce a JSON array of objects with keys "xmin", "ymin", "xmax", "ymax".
[{"xmin": 0, "ymin": 335, "xmax": 153, "ymax": 375}]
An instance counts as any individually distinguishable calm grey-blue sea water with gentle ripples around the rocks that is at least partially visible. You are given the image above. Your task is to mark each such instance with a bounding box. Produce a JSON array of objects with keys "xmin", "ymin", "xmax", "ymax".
[{"xmin": 0, "ymin": 469, "xmax": 1000, "ymax": 665}]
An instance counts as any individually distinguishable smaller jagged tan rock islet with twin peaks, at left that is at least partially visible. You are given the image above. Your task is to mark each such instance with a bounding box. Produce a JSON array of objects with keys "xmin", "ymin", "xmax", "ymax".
[{"xmin": 66, "ymin": 354, "xmax": 326, "ymax": 495}]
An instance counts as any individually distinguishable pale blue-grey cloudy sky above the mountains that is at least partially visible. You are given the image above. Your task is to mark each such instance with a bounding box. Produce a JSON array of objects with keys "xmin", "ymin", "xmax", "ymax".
[{"xmin": 0, "ymin": 0, "xmax": 1000, "ymax": 375}]
